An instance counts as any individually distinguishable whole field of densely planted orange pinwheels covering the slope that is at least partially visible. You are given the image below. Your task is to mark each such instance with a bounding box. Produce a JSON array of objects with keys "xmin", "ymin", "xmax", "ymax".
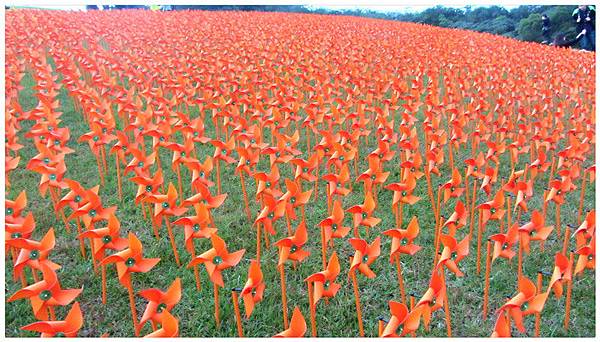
[{"xmin": 5, "ymin": 10, "xmax": 595, "ymax": 337}]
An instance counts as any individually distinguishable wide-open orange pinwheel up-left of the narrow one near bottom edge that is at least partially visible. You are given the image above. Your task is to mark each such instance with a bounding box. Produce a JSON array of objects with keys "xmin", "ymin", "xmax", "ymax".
[{"xmin": 100, "ymin": 232, "xmax": 160, "ymax": 289}]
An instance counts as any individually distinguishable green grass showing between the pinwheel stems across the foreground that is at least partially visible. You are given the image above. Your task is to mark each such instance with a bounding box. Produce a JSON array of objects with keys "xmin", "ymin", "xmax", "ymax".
[{"xmin": 5, "ymin": 68, "xmax": 595, "ymax": 337}]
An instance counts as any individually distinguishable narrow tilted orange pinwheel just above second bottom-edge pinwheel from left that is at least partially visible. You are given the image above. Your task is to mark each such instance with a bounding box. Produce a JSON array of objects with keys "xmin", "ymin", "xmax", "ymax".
[{"xmin": 137, "ymin": 278, "xmax": 181, "ymax": 336}]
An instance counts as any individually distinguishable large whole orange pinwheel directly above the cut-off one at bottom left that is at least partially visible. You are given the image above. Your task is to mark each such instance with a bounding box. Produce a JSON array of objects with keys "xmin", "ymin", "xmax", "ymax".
[{"xmin": 8, "ymin": 264, "xmax": 83, "ymax": 320}]
